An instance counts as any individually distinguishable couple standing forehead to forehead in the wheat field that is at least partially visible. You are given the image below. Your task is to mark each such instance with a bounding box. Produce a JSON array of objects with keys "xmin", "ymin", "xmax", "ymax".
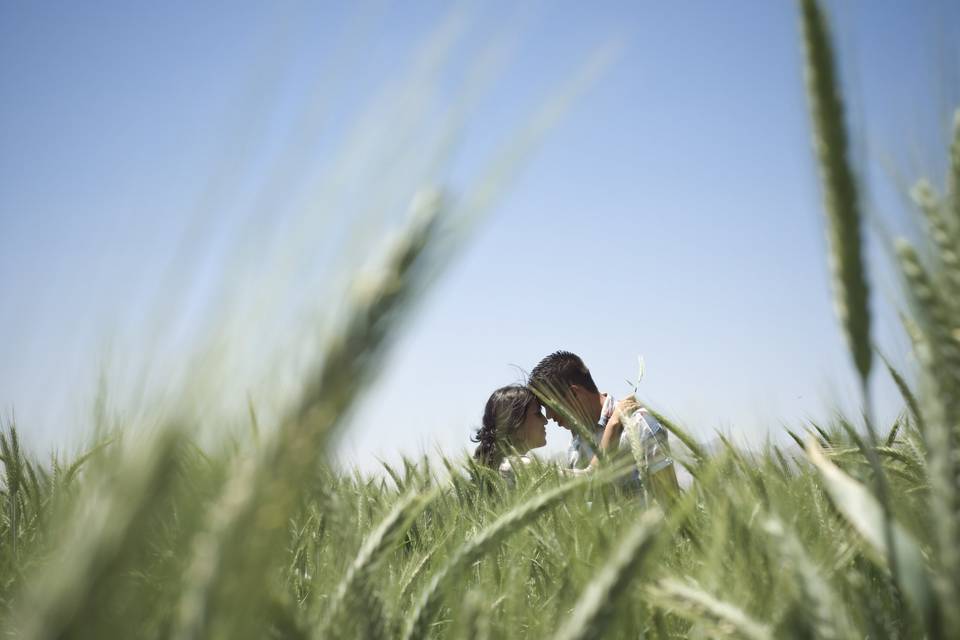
[{"xmin": 473, "ymin": 351, "xmax": 680, "ymax": 507}]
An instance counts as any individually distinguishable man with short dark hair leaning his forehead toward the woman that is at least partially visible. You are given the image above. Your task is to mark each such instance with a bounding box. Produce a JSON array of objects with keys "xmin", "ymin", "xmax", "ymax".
[{"xmin": 527, "ymin": 351, "xmax": 680, "ymax": 509}]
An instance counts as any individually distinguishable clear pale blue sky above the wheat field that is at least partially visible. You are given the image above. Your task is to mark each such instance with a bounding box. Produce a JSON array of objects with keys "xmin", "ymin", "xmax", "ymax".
[{"xmin": 0, "ymin": 0, "xmax": 960, "ymax": 468}]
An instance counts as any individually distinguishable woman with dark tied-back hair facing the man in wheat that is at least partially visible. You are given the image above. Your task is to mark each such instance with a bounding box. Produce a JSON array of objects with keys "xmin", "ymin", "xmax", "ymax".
[{"xmin": 471, "ymin": 384, "xmax": 547, "ymax": 478}]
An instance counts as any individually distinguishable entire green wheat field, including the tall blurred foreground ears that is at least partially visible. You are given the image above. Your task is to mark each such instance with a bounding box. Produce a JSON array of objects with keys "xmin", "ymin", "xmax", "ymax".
[{"xmin": 0, "ymin": 0, "xmax": 960, "ymax": 640}]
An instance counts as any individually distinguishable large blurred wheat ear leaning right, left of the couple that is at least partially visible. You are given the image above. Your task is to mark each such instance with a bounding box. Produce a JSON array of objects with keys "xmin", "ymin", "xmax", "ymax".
[{"xmin": 175, "ymin": 192, "xmax": 443, "ymax": 639}]
